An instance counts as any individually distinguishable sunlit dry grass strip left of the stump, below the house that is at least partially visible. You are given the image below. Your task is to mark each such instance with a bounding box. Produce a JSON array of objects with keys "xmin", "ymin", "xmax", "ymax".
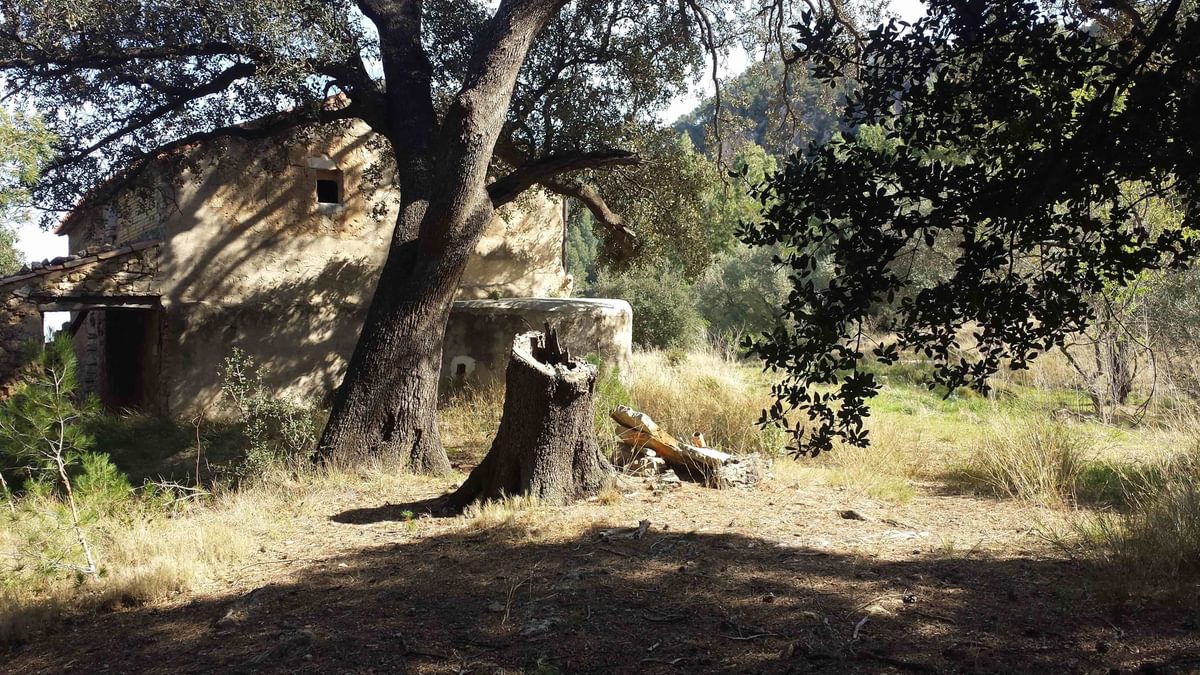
[{"xmin": 0, "ymin": 464, "xmax": 448, "ymax": 644}]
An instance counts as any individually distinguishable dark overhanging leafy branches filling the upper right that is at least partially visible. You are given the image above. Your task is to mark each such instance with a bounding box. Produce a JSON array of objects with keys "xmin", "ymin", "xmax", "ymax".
[{"xmin": 743, "ymin": 0, "xmax": 1200, "ymax": 453}]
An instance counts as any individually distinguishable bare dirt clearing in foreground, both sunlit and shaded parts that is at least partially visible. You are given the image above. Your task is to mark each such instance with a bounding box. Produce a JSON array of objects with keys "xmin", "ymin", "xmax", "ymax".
[{"xmin": 0, "ymin": 468, "xmax": 1200, "ymax": 674}]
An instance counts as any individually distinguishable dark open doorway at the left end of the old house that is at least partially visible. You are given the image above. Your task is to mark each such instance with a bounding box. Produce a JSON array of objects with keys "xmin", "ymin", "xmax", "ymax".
[{"xmin": 100, "ymin": 310, "xmax": 158, "ymax": 412}]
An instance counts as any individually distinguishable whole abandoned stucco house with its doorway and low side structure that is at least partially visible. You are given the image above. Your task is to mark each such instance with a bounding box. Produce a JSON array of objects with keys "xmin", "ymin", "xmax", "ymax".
[{"xmin": 0, "ymin": 123, "xmax": 631, "ymax": 416}]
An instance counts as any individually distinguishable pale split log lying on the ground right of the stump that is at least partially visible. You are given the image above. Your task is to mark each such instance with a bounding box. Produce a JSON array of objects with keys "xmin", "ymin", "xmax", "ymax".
[{"xmin": 610, "ymin": 406, "xmax": 768, "ymax": 488}]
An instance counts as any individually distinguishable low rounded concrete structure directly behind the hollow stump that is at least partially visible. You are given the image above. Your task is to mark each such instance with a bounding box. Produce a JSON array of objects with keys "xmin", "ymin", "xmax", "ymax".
[{"xmin": 442, "ymin": 298, "xmax": 634, "ymax": 384}]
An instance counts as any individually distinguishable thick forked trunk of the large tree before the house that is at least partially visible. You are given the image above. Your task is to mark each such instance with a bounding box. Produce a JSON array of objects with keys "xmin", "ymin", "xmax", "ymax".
[{"xmin": 317, "ymin": 0, "xmax": 566, "ymax": 473}]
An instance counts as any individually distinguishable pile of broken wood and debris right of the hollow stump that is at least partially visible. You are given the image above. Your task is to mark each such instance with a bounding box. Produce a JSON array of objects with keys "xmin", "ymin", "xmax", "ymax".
[{"xmin": 608, "ymin": 406, "xmax": 768, "ymax": 488}]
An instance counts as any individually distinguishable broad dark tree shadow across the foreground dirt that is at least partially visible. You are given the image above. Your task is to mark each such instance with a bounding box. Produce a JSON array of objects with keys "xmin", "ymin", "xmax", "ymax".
[{"xmin": 0, "ymin": 514, "xmax": 1200, "ymax": 674}]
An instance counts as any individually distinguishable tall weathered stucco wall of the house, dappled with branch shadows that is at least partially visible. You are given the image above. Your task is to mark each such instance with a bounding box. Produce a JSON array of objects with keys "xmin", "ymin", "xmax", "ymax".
[{"xmin": 57, "ymin": 123, "xmax": 590, "ymax": 416}]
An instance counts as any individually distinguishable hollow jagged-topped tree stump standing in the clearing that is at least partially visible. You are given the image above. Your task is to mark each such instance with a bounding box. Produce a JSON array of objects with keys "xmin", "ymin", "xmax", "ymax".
[{"xmin": 445, "ymin": 327, "xmax": 612, "ymax": 510}]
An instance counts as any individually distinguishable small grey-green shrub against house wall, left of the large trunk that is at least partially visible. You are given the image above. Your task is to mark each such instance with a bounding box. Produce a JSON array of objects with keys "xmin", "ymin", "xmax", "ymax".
[{"xmin": 221, "ymin": 347, "xmax": 320, "ymax": 476}]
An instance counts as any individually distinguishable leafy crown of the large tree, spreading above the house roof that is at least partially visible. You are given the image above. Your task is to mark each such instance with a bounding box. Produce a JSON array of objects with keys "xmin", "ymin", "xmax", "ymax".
[{"xmin": 0, "ymin": 0, "xmax": 772, "ymax": 227}]
